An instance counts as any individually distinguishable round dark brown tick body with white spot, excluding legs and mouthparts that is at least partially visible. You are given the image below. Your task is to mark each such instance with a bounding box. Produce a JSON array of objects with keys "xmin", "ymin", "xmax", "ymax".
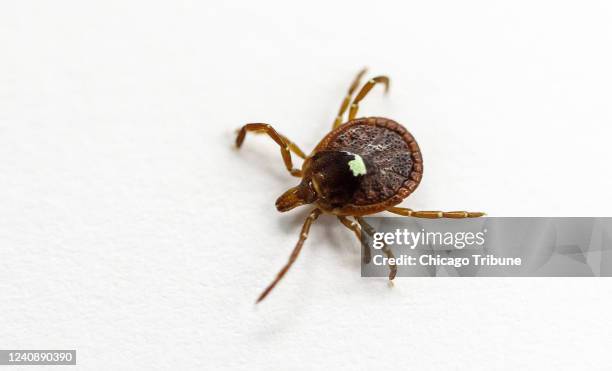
[{"xmin": 303, "ymin": 117, "xmax": 423, "ymax": 216}]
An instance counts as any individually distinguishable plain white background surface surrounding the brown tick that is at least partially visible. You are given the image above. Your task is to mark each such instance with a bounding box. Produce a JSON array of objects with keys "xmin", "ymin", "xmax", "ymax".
[{"xmin": 0, "ymin": 0, "xmax": 612, "ymax": 370}]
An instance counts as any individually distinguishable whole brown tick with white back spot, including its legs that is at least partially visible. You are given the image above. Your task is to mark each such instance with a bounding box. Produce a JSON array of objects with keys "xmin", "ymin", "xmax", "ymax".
[{"xmin": 236, "ymin": 69, "xmax": 484, "ymax": 303}]
